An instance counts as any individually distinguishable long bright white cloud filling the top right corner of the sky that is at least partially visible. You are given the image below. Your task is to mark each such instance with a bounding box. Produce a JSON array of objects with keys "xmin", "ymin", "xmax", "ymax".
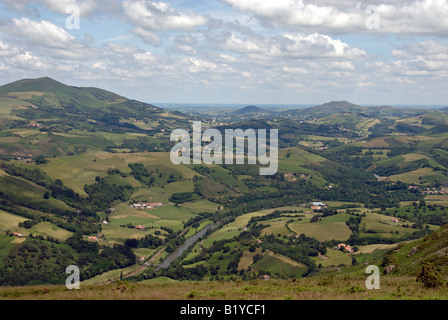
[{"xmin": 226, "ymin": 0, "xmax": 448, "ymax": 37}]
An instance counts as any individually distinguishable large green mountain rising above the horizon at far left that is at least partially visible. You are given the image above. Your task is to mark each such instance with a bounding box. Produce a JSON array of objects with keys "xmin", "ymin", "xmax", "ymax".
[{"xmin": 0, "ymin": 77, "xmax": 189, "ymax": 131}]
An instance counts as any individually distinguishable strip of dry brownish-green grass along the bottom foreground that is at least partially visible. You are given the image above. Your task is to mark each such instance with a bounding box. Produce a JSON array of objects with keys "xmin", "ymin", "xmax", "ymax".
[{"xmin": 0, "ymin": 275, "xmax": 448, "ymax": 300}]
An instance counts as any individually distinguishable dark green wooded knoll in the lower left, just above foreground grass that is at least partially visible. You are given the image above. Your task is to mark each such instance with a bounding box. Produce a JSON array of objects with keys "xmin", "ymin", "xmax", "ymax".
[{"xmin": 0, "ymin": 236, "xmax": 135, "ymax": 286}]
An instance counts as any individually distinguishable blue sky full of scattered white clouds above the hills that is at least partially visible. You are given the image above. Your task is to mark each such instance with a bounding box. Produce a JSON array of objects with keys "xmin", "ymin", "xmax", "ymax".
[{"xmin": 0, "ymin": 0, "xmax": 448, "ymax": 105}]
